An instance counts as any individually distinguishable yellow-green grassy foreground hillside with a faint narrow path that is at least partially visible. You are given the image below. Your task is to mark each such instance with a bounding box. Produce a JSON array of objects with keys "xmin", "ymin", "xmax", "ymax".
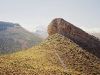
[{"xmin": 0, "ymin": 34, "xmax": 100, "ymax": 75}]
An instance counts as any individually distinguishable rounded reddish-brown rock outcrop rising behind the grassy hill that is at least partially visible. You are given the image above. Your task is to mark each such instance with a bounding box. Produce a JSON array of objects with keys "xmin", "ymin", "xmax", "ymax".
[{"xmin": 48, "ymin": 18, "xmax": 100, "ymax": 57}]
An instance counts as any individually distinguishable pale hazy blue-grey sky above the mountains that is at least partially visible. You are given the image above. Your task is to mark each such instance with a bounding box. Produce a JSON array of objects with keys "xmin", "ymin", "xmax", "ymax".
[{"xmin": 0, "ymin": 0, "xmax": 100, "ymax": 32}]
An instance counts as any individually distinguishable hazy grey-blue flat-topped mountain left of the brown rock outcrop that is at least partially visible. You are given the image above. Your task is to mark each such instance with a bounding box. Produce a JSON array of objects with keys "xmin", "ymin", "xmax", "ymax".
[{"xmin": 0, "ymin": 21, "xmax": 42, "ymax": 54}]
